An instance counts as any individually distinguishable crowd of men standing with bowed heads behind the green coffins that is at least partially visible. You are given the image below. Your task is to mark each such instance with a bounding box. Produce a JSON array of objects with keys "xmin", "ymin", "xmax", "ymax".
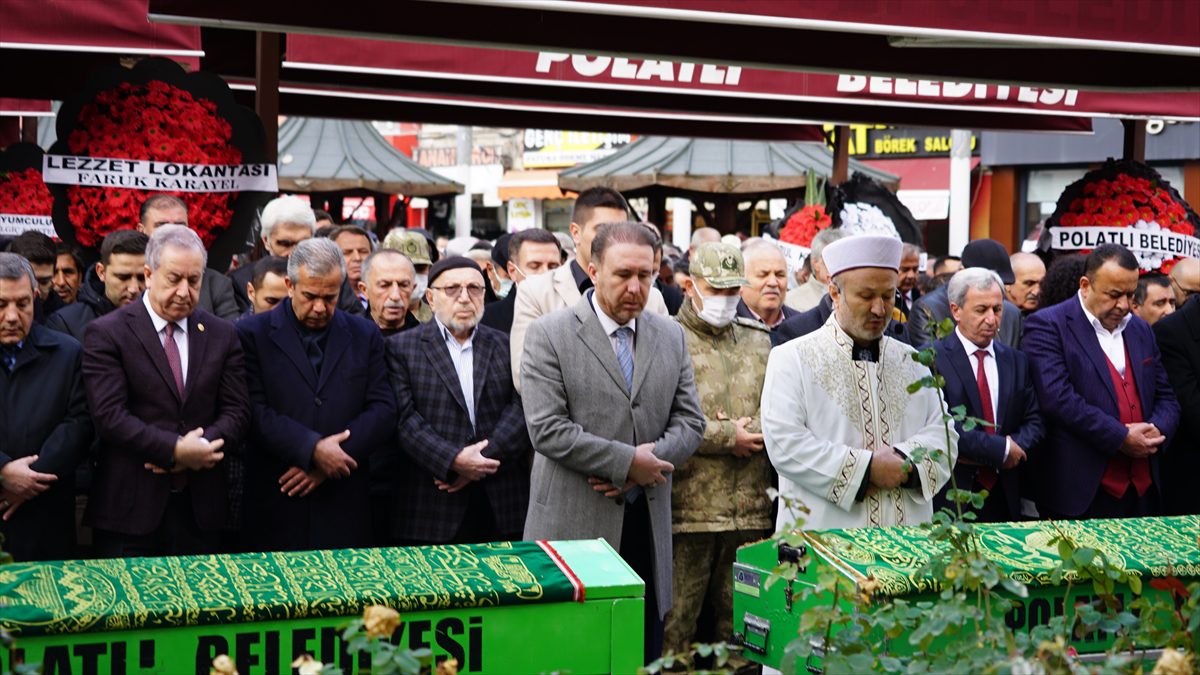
[{"xmin": 0, "ymin": 189, "xmax": 1200, "ymax": 661}]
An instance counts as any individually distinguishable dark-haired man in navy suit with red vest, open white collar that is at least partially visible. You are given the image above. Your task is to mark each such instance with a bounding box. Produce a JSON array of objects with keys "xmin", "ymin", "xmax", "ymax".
[{"xmin": 1021, "ymin": 244, "xmax": 1180, "ymax": 518}]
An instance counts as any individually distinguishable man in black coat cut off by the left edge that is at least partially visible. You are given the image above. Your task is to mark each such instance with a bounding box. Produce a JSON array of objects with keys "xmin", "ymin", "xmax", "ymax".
[{"xmin": 0, "ymin": 253, "xmax": 92, "ymax": 562}]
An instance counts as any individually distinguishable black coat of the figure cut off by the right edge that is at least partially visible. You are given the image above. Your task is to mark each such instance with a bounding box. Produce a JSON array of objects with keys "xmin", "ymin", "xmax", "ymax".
[{"xmin": 1153, "ymin": 295, "xmax": 1200, "ymax": 515}]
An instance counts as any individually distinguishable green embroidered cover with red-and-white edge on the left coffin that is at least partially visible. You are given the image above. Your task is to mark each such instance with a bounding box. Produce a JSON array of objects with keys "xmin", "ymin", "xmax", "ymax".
[{"xmin": 0, "ymin": 542, "xmax": 583, "ymax": 635}]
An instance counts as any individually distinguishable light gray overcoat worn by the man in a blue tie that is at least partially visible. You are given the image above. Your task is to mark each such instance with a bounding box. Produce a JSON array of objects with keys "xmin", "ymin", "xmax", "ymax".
[{"xmin": 521, "ymin": 291, "xmax": 704, "ymax": 615}]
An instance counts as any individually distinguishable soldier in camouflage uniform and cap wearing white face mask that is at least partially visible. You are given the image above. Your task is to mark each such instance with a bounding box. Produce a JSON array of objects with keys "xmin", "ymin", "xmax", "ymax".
[{"xmin": 665, "ymin": 243, "xmax": 773, "ymax": 652}]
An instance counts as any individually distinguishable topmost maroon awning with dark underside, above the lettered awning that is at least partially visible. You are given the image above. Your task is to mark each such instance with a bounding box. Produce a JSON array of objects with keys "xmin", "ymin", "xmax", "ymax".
[{"xmin": 150, "ymin": 0, "xmax": 1200, "ymax": 90}]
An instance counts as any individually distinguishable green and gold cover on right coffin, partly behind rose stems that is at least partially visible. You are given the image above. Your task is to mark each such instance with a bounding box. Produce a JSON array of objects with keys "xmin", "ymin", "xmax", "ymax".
[{"xmin": 804, "ymin": 515, "xmax": 1200, "ymax": 597}]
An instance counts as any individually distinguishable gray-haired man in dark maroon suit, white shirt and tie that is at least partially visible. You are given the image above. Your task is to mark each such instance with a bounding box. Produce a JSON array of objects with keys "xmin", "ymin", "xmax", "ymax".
[{"xmin": 83, "ymin": 225, "xmax": 250, "ymax": 557}]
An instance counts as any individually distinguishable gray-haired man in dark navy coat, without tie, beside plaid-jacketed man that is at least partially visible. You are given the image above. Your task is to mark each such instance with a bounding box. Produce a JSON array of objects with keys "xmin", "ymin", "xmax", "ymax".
[{"xmin": 238, "ymin": 239, "xmax": 396, "ymax": 550}]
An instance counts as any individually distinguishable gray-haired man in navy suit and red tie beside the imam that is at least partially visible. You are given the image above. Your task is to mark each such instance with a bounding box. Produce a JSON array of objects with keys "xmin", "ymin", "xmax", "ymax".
[{"xmin": 936, "ymin": 267, "xmax": 1043, "ymax": 522}]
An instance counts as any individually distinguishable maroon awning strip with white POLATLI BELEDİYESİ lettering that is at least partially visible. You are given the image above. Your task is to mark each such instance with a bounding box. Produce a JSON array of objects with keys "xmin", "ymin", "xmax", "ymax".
[{"xmin": 283, "ymin": 34, "xmax": 1200, "ymax": 131}]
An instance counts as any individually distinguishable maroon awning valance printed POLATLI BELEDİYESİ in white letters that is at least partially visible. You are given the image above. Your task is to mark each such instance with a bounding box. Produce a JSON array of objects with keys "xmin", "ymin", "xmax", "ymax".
[{"xmin": 284, "ymin": 36, "xmax": 1200, "ymax": 124}]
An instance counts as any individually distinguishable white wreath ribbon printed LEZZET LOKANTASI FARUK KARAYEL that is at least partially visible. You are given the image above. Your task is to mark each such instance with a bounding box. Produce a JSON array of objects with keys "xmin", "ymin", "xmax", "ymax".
[{"xmin": 42, "ymin": 155, "xmax": 278, "ymax": 192}]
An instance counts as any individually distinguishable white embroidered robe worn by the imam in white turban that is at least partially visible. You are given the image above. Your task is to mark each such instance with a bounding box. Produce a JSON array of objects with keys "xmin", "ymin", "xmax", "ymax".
[{"xmin": 762, "ymin": 315, "xmax": 958, "ymax": 530}]
